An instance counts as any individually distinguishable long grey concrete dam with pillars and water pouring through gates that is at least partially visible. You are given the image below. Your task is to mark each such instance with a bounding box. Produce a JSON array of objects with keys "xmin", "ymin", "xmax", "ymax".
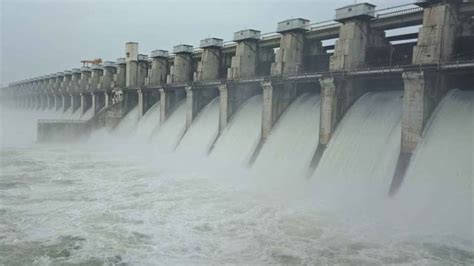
[{"xmin": 1, "ymin": 1, "xmax": 474, "ymax": 195}]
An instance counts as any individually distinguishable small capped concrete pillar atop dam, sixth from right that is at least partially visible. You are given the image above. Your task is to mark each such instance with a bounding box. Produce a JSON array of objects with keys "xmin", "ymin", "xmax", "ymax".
[{"xmin": 167, "ymin": 44, "xmax": 193, "ymax": 84}]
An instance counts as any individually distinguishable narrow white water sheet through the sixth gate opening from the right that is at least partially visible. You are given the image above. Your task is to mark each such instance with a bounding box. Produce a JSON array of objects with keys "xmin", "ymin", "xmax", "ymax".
[{"xmin": 152, "ymin": 101, "xmax": 186, "ymax": 153}]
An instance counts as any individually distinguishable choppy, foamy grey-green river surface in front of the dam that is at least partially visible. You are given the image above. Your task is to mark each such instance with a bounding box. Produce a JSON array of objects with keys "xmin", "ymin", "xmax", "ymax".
[{"xmin": 0, "ymin": 91, "xmax": 474, "ymax": 265}]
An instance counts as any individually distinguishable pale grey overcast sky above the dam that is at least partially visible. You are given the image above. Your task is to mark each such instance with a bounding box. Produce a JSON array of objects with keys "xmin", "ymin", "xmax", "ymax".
[{"xmin": 0, "ymin": 0, "xmax": 414, "ymax": 85}]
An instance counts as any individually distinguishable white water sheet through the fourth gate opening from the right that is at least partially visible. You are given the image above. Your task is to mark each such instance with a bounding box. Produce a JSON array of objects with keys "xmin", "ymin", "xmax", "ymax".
[{"xmin": 211, "ymin": 95, "xmax": 262, "ymax": 165}]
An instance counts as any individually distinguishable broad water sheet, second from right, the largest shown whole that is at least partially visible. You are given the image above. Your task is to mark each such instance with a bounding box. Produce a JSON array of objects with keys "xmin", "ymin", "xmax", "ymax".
[{"xmin": 312, "ymin": 91, "xmax": 403, "ymax": 200}]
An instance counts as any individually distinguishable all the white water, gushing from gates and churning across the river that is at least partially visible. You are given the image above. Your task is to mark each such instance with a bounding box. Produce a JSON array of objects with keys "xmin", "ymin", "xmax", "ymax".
[{"xmin": 0, "ymin": 91, "xmax": 474, "ymax": 265}]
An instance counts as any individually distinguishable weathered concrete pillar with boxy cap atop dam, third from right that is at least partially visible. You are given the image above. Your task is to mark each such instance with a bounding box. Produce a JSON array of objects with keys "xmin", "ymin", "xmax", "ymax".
[{"xmin": 271, "ymin": 18, "xmax": 309, "ymax": 76}]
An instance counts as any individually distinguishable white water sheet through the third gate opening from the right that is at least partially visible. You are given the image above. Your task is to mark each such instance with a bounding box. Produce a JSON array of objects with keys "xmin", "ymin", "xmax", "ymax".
[{"xmin": 252, "ymin": 93, "xmax": 320, "ymax": 183}]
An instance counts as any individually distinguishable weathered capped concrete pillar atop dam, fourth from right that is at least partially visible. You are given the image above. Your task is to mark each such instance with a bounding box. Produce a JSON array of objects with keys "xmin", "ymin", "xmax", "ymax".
[{"xmin": 227, "ymin": 30, "xmax": 260, "ymax": 80}]
